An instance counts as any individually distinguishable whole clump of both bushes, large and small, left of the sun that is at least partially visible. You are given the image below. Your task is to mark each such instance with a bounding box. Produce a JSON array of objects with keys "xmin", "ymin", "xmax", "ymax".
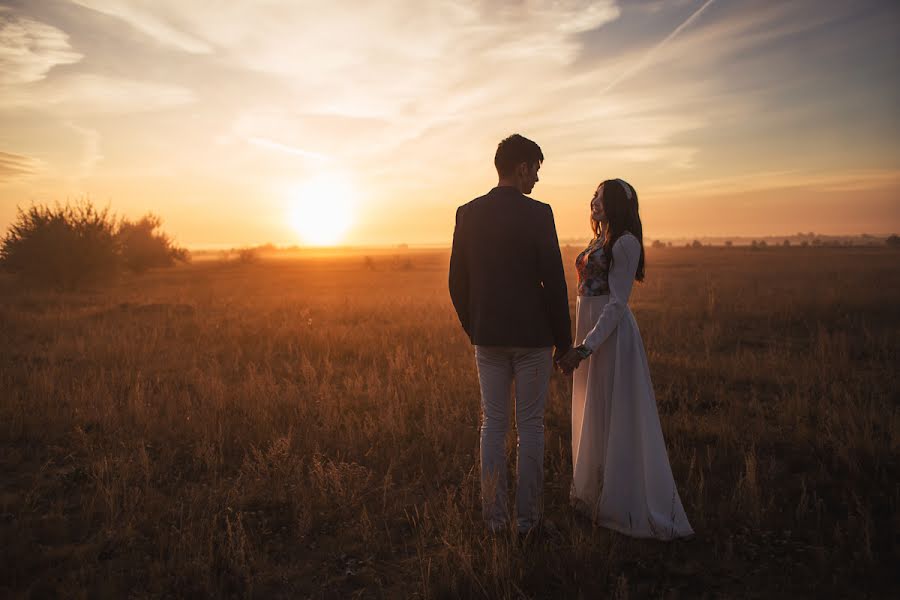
[{"xmin": 0, "ymin": 201, "xmax": 188, "ymax": 288}]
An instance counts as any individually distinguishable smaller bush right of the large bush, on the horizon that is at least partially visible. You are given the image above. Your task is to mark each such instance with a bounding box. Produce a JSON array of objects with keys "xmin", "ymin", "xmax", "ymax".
[{"xmin": 116, "ymin": 214, "xmax": 189, "ymax": 273}]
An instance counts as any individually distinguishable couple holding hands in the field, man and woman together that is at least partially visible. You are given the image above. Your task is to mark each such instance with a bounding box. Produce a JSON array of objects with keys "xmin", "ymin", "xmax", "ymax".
[{"xmin": 450, "ymin": 134, "xmax": 693, "ymax": 539}]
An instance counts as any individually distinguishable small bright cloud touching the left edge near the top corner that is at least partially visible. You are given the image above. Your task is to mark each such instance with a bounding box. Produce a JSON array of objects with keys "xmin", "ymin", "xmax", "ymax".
[{"xmin": 0, "ymin": 8, "xmax": 83, "ymax": 85}]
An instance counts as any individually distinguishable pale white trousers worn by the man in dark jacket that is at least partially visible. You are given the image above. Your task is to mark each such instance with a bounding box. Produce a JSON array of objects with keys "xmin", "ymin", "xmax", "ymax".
[{"xmin": 475, "ymin": 346, "xmax": 553, "ymax": 531}]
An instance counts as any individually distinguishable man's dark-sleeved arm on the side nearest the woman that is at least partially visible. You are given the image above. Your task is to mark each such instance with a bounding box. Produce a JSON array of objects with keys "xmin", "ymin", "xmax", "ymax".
[{"xmin": 538, "ymin": 206, "xmax": 572, "ymax": 355}]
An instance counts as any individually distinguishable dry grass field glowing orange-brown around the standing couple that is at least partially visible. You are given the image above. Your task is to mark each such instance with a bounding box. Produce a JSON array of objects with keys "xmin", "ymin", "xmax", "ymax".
[{"xmin": 0, "ymin": 247, "xmax": 900, "ymax": 598}]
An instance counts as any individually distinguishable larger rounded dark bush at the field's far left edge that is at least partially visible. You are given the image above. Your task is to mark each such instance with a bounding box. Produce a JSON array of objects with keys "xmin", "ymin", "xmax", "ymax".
[{"xmin": 0, "ymin": 201, "xmax": 120, "ymax": 288}]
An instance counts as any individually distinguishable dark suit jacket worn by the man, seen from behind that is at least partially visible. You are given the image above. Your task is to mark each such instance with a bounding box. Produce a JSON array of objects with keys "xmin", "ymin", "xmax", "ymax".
[{"xmin": 450, "ymin": 186, "xmax": 572, "ymax": 350}]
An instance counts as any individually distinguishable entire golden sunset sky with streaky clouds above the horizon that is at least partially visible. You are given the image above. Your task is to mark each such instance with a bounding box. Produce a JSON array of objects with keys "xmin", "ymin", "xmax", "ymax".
[{"xmin": 0, "ymin": 0, "xmax": 900, "ymax": 248}]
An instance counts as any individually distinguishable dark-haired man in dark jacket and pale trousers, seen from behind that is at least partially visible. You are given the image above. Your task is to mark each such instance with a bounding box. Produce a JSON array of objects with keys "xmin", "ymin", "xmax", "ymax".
[{"xmin": 450, "ymin": 134, "xmax": 574, "ymax": 533}]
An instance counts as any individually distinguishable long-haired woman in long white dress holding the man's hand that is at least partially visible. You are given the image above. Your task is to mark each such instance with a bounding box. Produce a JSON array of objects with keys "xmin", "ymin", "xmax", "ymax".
[{"xmin": 560, "ymin": 179, "xmax": 694, "ymax": 539}]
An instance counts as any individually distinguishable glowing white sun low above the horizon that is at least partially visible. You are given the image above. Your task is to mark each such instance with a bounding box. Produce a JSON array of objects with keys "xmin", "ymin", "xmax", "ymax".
[{"xmin": 290, "ymin": 173, "xmax": 356, "ymax": 246}]
